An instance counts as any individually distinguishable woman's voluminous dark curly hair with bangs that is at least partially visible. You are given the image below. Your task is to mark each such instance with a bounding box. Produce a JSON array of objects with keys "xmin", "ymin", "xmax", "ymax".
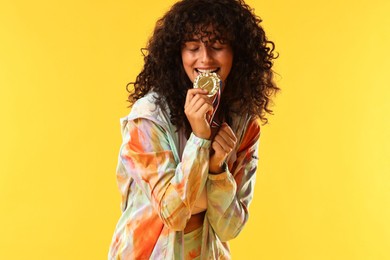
[{"xmin": 127, "ymin": 0, "xmax": 279, "ymax": 131}]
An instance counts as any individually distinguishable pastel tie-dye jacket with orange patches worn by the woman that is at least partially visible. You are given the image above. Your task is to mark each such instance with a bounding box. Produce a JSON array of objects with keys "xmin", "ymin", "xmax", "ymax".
[{"xmin": 108, "ymin": 93, "xmax": 260, "ymax": 259}]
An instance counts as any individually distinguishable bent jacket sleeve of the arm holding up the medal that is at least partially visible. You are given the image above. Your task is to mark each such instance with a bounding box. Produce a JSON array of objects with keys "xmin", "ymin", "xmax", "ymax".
[{"xmin": 117, "ymin": 118, "xmax": 210, "ymax": 230}]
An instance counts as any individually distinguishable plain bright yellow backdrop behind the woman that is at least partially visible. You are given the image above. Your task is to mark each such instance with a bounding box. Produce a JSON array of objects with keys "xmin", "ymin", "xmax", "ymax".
[{"xmin": 0, "ymin": 0, "xmax": 390, "ymax": 260}]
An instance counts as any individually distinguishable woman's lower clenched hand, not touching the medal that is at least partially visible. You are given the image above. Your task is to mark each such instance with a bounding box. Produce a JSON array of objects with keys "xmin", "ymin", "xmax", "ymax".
[{"xmin": 209, "ymin": 123, "xmax": 237, "ymax": 174}]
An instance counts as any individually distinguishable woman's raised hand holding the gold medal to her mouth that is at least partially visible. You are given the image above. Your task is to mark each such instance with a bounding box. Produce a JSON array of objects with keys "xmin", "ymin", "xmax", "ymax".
[{"xmin": 184, "ymin": 88, "xmax": 213, "ymax": 139}]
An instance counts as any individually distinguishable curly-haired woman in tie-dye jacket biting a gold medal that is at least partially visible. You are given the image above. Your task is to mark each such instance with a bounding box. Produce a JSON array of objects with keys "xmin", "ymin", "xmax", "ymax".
[{"xmin": 109, "ymin": 0, "xmax": 278, "ymax": 259}]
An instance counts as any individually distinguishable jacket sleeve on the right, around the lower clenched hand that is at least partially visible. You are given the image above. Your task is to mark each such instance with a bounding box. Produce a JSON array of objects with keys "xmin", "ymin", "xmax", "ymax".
[{"xmin": 206, "ymin": 120, "xmax": 260, "ymax": 242}]
